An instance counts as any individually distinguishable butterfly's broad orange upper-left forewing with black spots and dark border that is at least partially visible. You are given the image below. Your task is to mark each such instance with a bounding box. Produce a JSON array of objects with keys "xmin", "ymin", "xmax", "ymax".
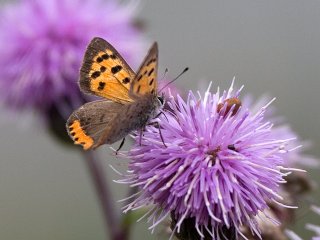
[{"xmin": 80, "ymin": 37, "xmax": 135, "ymax": 103}]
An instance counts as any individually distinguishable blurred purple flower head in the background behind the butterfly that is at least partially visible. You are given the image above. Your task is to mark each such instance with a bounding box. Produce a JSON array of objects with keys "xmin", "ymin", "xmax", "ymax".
[{"xmin": 0, "ymin": 0, "xmax": 144, "ymax": 111}]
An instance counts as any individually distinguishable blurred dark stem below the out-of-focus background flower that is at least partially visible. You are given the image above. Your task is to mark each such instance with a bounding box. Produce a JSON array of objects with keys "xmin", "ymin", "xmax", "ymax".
[{"xmin": 84, "ymin": 151, "xmax": 128, "ymax": 240}]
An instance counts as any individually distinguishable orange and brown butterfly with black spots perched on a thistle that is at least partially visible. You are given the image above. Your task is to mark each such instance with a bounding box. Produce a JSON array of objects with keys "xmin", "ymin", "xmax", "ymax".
[{"xmin": 66, "ymin": 37, "xmax": 163, "ymax": 150}]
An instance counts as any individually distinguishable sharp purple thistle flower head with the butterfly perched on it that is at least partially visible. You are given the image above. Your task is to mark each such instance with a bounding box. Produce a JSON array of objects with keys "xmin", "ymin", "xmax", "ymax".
[{"xmin": 120, "ymin": 82, "xmax": 298, "ymax": 239}]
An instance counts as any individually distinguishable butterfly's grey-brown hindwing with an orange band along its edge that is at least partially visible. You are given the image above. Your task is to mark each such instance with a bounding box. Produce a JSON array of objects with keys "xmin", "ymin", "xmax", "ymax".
[{"xmin": 67, "ymin": 100, "xmax": 126, "ymax": 150}]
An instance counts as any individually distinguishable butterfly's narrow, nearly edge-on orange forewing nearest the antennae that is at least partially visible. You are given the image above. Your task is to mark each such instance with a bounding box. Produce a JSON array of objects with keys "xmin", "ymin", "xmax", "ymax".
[{"xmin": 130, "ymin": 42, "xmax": 158, "ymax": 96}]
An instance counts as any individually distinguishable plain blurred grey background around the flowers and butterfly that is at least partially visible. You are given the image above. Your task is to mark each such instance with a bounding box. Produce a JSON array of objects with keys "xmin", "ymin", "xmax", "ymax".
[{"xmin": 0, "ymin": 0, "xmax": 320, "ymax": 240}]
